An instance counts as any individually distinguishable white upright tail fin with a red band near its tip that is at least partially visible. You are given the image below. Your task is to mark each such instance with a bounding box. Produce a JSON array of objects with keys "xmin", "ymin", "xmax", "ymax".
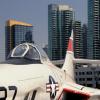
[{"xmin": 62, "ymin": 30, "xmax": 74, "ymax": 81}]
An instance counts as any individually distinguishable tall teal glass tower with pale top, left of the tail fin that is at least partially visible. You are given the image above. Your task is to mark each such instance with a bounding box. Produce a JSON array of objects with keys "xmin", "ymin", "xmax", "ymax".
[{"xmin": 48, "ymin": 4, "xmax": 73, "ymax": 60}]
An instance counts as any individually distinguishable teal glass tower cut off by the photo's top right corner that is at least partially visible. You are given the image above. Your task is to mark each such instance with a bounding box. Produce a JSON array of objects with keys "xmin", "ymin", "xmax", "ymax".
[{"xmin": 87, "ymin": 0, "xmax": 100, "ymax": 59}]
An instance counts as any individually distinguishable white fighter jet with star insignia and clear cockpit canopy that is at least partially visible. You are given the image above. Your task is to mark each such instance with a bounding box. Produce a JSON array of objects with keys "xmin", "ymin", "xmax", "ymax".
[{"xmin": 0, "ymin": 32, "xmax": 100, "ymax": 100}]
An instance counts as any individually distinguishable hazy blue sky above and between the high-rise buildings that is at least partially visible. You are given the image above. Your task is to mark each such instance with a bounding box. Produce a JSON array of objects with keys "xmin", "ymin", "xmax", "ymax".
[{"xmin": 0, "ymin": 0, "xmax": 87, "ymax": 60}]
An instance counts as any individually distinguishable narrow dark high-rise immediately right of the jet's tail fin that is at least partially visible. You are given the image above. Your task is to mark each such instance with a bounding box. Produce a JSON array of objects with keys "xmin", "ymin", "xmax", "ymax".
[{"xmin": 73, "ymin": 21, "xmax": 83, "ymax": 58}]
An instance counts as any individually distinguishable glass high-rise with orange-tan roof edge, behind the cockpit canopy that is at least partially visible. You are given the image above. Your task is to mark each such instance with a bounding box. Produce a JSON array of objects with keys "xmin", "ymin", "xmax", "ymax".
[{"xmin": 5, "ymin": 20, "xmax": 33, "ymax": 59}]
